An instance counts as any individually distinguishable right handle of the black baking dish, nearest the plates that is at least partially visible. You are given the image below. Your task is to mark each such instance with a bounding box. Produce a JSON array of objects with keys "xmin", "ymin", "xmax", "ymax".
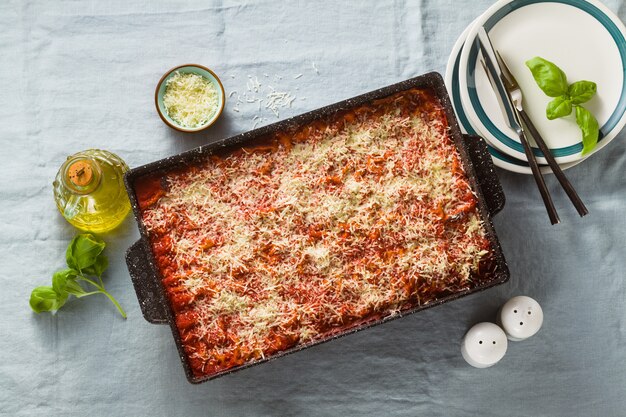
[{"xmin": 463, "ymin": 135, "xmax": 506, "ymax": 217}]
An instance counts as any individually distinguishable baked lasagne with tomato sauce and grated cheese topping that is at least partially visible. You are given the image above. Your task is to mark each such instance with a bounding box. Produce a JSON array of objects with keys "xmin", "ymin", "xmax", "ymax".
[{"xmin": 135, "ymin": 89, "xmax": 495, "ymax": 377}]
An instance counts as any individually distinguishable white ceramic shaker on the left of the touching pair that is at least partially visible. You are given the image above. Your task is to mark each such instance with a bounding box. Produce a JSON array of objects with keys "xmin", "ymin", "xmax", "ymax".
[{"xmin": 461, "ymin": 322, "xmax": 508, "ymax": 368}]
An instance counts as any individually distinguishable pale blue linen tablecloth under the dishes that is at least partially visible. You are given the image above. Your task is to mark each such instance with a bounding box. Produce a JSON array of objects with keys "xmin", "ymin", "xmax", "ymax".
[{"xmin": 0, "ymin": 0, "xmax": 626, "ymax": 416}]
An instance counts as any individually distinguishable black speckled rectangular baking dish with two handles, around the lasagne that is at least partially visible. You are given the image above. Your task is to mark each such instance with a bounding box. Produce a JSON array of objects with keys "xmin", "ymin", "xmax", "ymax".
[{"xmin": 124, "ymin": 72, "xmax": 509, "ymax": 383}]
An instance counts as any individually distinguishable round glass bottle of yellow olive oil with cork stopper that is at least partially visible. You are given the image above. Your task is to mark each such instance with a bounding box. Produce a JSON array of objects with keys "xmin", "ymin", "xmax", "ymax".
[{"xmin": 52, "ymin": 149, "xmax": 130, "ymax": 233}]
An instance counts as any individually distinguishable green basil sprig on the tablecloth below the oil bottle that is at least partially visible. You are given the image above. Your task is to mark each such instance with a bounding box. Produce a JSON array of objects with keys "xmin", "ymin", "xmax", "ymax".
[{"xmin": 30, "ymin": 233, "xmax": 126, "ymax": 318}]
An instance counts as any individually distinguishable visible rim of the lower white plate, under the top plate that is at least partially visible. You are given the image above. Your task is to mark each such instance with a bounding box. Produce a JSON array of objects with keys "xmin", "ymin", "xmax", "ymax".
[{"xmin": 445, "ymin": 18, "xmax": 582, "ymax": 175}]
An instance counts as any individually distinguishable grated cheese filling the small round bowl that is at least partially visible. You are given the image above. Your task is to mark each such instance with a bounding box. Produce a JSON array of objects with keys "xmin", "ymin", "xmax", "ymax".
[{"xmin": 163, "ymin": 71, "xmax": 218, "ymax": 128}]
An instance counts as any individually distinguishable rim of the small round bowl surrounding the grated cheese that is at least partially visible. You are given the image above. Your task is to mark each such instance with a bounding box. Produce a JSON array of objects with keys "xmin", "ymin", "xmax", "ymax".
[{"xmin": 154, "ymin": 64, "xmax": 226, "ymax": 132}]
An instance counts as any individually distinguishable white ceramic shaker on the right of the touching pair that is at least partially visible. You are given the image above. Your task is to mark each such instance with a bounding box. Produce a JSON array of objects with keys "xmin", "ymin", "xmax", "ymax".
[{"xmin": 498, "ymin": 295, "xmax": 543, "ymax": 342}]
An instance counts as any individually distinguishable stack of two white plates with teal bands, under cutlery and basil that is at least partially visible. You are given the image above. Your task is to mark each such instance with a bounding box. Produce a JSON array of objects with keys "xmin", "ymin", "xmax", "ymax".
[{"xmin": 445, "ymin": 0, "xmax": 626, "ymax": 174}]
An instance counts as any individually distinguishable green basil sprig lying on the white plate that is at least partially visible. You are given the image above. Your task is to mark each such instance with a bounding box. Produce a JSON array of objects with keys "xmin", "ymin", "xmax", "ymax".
[{"xmin": 526, "ymin": 56, "xmax": 600, "ymax": 155}]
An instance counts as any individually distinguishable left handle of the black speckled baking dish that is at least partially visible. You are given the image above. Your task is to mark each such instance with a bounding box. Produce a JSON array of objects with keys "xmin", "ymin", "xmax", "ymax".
[{"xmin": 126, "ymin": 240, "xmax": 167, "ymax": 324}]
